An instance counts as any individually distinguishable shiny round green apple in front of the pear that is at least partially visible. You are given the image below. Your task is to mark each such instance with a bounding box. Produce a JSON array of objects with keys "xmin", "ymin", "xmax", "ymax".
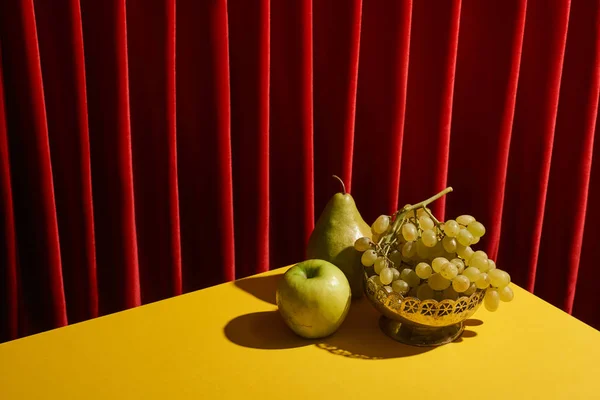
[{"xmin": 277, "ymin": 259, "xmax": 351, "ymax": 339}]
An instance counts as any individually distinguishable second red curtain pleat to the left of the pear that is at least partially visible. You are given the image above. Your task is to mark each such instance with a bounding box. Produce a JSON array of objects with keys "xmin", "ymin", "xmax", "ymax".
[{"xmin": 227, "ymin": 0, "xmax": 270, "ymax": 278}]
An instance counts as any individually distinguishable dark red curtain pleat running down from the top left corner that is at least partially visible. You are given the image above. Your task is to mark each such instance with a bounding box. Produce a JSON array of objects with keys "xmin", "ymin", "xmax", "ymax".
[{"xmin": 0, "ymin": 0, "xmax": 68, "ymax": 332}]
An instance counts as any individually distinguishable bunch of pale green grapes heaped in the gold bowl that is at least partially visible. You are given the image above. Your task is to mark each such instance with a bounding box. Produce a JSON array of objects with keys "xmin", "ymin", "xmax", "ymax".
[{"xmin": 354, "ymin": 189, "xmax": 514, "ymax": 311}]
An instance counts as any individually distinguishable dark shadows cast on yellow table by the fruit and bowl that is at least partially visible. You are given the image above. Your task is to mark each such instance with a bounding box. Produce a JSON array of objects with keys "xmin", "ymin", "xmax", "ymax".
[{"xmin": 224, "ymin": 274, "xmax": 483, "ymax": 360}]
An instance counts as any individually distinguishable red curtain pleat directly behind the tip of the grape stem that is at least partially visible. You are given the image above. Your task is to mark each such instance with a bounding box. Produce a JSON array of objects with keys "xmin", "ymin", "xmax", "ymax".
[{"xmin": 398, "ymin": 0, "xmax": 461, "ymax": 218}]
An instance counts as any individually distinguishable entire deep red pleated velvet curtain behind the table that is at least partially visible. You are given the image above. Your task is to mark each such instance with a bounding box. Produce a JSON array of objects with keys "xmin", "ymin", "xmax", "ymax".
[{"xmin": 0, "ymin": 0, "xmax": 600, "ymax": 341}]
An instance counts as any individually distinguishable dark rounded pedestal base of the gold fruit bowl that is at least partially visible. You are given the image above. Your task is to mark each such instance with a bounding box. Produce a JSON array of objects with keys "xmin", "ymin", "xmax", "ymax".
[{"xmin": 379, "ymin": 316, "xmax": 464, "ymax": 346}]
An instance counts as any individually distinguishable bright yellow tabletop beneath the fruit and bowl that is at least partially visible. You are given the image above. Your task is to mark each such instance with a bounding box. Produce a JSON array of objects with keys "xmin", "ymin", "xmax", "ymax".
[{"xmin": 0, "ymin": 269, "xmax": 600, "ymax": 400}]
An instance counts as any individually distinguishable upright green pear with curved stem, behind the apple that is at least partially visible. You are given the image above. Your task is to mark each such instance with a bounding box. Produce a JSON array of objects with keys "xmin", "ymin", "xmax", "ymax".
[{"xmin": 306, "ymin": 175, "xmax": 371, "ymax": 298}]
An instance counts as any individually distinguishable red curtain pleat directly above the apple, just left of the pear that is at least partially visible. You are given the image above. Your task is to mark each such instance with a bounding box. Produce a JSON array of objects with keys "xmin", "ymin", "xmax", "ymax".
[{"xmin": 269, "ymin": 0, "xmax": 314, "ymax": 266}]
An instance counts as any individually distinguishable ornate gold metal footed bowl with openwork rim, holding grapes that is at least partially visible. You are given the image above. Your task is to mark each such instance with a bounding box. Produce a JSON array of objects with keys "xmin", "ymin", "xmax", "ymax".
[{"xmin": 364, "ymin": 271, "xmax": 486, "ymax": 346}]
